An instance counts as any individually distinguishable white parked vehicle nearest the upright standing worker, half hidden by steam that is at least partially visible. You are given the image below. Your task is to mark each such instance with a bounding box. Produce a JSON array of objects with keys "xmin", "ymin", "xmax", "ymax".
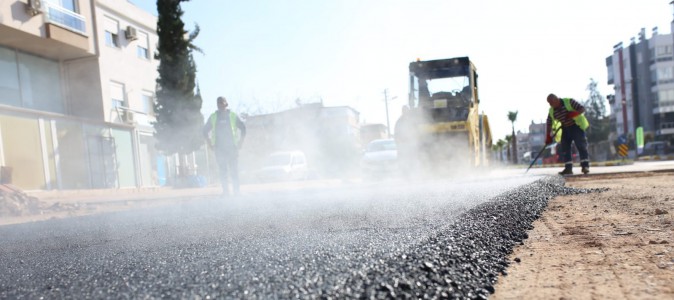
[{"xmin": 257, "ymin": 151, "xmax": 309, "ymax": 182}]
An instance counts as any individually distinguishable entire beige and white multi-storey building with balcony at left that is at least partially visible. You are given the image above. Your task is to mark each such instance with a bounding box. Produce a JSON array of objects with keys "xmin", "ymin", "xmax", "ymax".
[{"xmin": 0, "ymin": 0, "xmax": 162, "ymax": 190}]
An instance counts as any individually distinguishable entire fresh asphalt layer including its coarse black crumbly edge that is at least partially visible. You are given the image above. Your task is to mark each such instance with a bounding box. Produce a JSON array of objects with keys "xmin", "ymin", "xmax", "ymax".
[{"xmin": 0, "ymin": 177, "xmax": 591, "ymax": 299}]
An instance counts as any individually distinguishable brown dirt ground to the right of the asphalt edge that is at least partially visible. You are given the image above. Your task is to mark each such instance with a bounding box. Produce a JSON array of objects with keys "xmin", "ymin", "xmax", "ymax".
[{"xmin": 490, "ymin": 172, "xmax": 674, "ymax": 299}]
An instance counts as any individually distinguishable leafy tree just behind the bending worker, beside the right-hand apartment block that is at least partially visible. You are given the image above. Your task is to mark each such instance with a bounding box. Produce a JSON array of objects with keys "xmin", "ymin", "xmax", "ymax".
[{"xmin": 583, "ymin": 78, "xmax": 611, "ymax": 144}]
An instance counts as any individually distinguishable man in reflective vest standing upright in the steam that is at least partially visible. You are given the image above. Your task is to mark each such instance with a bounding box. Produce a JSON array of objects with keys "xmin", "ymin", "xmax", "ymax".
[{"xmin": 203, "ymin": 97, "xmax": 246, "ymax": 196}]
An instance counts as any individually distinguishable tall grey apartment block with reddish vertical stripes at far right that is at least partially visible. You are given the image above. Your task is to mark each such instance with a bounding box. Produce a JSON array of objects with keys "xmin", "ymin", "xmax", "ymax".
[{"xmin": 606, "ymin": 23, "xmax": 674, "ymax": 146}]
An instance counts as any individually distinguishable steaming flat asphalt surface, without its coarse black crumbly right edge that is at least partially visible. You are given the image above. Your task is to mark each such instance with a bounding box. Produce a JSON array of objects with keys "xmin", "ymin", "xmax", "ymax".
[{"xmin": 0, "ymin": 175, "xmax": 542, "ymax": 299}]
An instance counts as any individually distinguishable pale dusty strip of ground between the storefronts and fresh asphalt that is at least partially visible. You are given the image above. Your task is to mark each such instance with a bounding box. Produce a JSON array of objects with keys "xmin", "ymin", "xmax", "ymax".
[{"xmin": 0, "ymin": 179, "xmax": 346, "ymax": 226}]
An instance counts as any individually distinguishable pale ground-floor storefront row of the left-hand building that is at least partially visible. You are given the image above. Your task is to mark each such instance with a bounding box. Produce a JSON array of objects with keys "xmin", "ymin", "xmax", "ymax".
[{"xmin": 0, "ymin": 112, "xmax": 209, "ymax": 190}]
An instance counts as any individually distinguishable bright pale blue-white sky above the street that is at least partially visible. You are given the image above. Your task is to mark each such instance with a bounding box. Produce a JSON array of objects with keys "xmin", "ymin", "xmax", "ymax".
[{"xmin": 130, "ymin": 0, "xmax": 674, "ymax": 141}]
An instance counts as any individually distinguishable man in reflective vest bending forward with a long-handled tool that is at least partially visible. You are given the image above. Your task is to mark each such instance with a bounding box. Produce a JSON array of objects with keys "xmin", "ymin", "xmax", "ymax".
[{"xmin": 545, "ymin": 94, "xmax": 590, "ymax": 175}]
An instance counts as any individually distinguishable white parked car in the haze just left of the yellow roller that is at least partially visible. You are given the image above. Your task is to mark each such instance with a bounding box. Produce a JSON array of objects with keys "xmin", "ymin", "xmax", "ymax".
[{"xmin": 360, "ymin": 139, "xmax": 398, "ymax": 178}]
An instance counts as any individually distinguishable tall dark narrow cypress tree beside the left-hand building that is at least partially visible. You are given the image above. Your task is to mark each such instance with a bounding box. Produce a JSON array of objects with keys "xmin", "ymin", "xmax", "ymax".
[{"xmin": 154, "ymin": 0, "xmax": 204, "ymax": 175}]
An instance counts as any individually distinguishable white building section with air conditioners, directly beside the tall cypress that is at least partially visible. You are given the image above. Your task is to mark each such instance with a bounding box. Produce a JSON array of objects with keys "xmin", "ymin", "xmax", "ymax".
[{"xmin": 94, "ymin": 0, "xmax": 161, "ymax": 186}]
